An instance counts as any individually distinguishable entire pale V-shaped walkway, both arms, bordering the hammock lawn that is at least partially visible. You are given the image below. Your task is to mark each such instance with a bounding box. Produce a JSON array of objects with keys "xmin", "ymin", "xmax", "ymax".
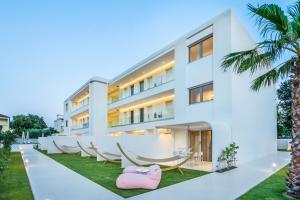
[{"xmin": 22, "ymin": 146, "xmax": 290, "ymax": 200}]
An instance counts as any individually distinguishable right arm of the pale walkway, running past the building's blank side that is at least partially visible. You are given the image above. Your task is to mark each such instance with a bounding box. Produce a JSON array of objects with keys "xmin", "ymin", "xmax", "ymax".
[{"xmin": 130, "ymin": 152, "xmax": 290, "ymax": 200}]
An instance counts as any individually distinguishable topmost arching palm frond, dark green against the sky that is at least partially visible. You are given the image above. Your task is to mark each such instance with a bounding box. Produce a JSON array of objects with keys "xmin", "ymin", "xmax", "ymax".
[{"xmin": 248, "ymin": 4, "xmax": 289, "ymax": 38}]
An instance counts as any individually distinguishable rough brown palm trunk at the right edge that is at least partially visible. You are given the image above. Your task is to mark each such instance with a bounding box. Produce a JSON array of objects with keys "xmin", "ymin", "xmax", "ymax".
[{"xmin": 286, "ymin": 58, "xmax": 300, "ymax": 199}]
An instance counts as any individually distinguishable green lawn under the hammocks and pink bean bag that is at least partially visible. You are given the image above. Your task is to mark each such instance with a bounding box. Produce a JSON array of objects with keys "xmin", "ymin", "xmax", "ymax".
[{"xmin": 38, "ymin": 151, "xmax": 208, "ymax": 198}]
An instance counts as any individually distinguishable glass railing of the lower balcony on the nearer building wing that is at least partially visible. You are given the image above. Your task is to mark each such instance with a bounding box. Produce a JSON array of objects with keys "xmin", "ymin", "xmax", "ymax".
[{"xmin": 108, "ymin": 108, "xmax": 174, "ymax": 127}]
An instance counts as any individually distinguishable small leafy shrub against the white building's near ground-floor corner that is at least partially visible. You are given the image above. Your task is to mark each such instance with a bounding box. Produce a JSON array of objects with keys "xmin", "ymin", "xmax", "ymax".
[{"xmin": 218, "ymin": 142, "xmax": 239, "ymax": 168}]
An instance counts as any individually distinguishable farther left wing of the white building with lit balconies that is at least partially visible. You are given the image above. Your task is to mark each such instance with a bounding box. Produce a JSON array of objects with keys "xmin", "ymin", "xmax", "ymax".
[{"xmin": 64, "ymin": 77, "xmax": 108, "ymax": 135}]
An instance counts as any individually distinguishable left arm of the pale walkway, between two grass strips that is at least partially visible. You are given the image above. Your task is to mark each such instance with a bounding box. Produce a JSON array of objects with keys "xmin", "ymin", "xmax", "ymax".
[{"xmin": 20, "ymin": 145, "xmax": 123, "ymax": 200}]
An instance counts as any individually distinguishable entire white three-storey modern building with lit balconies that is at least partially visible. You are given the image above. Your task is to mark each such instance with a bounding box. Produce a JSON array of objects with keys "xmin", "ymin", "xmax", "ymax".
[{"xmin": 64, "ymin": 10, "xmax": 276, "ymax": 170}]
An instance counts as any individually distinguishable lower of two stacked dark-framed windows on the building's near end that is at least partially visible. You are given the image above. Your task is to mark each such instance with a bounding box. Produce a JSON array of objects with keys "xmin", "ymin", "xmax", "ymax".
[{"xmin": 189, "ymin": 83, "xmax": 214, "ymax": 104}]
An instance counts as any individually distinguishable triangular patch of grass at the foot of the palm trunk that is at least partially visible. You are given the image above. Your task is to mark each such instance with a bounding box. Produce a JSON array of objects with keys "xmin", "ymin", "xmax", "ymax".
[{"xmin": 239, "ymin": 167, "xmax": 288, "ymax": 200}]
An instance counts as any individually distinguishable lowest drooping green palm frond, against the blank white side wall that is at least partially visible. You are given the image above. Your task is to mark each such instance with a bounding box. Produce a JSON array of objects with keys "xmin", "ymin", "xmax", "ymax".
[{"xmin": 251, "ymin": 58, "xmax": 296, "ymax": 91}]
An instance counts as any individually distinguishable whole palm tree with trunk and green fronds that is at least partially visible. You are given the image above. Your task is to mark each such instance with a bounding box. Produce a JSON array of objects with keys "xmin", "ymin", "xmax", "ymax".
[{"xmin": 222, "ymin": 0, "xmax": 300, "ymax": 199}]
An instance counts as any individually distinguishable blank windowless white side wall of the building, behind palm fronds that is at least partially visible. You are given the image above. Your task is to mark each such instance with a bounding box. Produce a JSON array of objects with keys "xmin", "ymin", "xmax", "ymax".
[{"xmin": 231, "ymin": 12, "xmax": 277, "ymax": 164}]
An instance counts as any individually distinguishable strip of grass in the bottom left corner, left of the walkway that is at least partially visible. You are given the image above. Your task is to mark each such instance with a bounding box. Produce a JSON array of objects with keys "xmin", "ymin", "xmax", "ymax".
[{"xmin": 0, "ymin": 152, "xmax": 33, "ymax": 200}]
